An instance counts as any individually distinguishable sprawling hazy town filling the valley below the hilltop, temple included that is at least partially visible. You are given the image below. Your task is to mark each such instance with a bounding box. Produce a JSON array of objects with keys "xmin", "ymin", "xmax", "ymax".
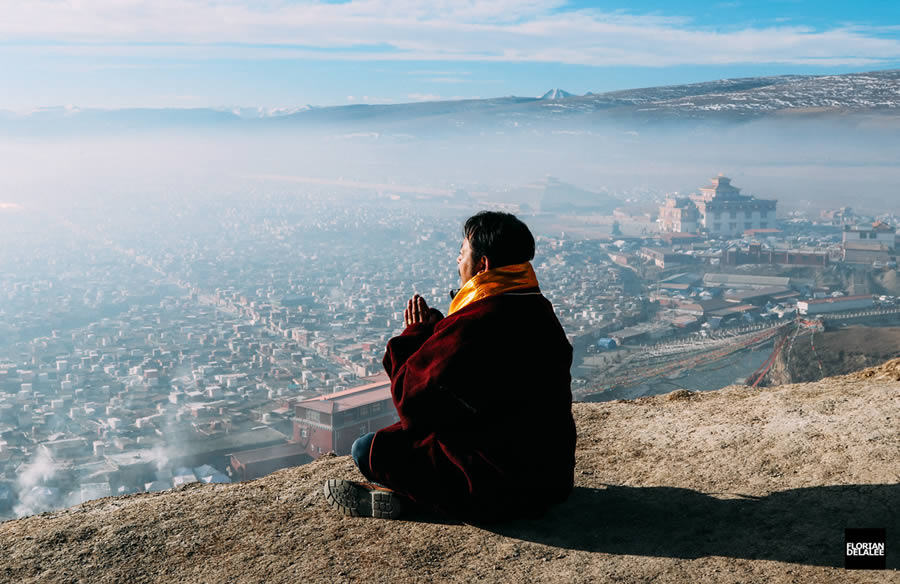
[{"xmin": 0, "ymin": 173, "xmax": 900, "ymax": 518}]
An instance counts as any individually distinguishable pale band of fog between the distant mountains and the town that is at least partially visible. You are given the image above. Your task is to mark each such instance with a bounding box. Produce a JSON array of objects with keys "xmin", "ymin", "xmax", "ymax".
[{"xmin": 0, "ymin": 110, "xmax": 900, "ymax": 211}]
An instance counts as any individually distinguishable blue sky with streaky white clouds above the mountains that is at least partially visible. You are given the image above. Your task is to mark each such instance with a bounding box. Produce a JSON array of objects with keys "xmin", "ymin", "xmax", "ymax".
[{"xmin": 0, "ymin": 0, "xmax": 900, "ymax": 112}]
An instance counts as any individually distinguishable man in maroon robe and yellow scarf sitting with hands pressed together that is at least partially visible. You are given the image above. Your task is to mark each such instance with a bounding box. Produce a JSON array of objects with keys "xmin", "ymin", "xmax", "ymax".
[{"xmin": 325, "ymin": 211, "xmax": 575, "ymax": 519}]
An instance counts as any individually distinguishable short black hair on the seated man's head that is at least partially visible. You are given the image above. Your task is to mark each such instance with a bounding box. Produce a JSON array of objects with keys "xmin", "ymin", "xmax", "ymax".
[{"xmin": 463, "ymin": 211, "xmax": 534, "ymax": 268}]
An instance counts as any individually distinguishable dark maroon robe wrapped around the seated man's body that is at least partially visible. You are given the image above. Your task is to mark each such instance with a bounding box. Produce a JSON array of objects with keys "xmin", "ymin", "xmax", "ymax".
[{"xmin": 369, "ymin": 288, "xmax": 575, "ymax": 518}]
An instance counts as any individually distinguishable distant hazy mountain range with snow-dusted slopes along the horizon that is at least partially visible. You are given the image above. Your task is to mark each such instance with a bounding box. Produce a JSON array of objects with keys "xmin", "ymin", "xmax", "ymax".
[{"xmin": 0, "ymin": 70, "xmax": 900, "ymax": 134}]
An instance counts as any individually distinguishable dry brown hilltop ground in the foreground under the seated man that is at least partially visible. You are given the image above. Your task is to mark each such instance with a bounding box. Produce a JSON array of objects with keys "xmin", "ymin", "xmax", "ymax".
[{"xmin": 0, "ymin": 360, "xmax": 900, "ymax": 583}]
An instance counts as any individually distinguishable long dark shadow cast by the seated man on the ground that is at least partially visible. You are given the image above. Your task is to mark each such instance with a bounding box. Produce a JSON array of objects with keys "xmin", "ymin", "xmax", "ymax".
[{"xmin": 480, "ymin": 484, "xmax": 900, "ymax": 569}]
